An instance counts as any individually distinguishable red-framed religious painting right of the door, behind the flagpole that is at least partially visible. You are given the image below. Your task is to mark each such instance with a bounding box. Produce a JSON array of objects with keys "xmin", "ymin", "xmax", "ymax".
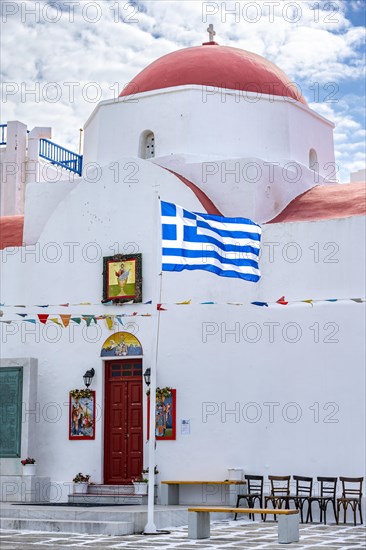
[{"xmin": 147, "ymin": 388, "xmax": 177, "ymax": 441}]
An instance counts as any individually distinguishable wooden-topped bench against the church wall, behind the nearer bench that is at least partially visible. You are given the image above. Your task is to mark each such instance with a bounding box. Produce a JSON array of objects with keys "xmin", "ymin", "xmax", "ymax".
[{"xmin": 160, "ymin": 480, "xmax": 246, "ymax": 506}]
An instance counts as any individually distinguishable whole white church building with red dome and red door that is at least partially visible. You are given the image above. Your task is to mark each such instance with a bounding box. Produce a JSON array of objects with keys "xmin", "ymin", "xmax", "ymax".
[{"xmin": 0, "ymin": 34, "xmax": 366, "ymax": 528}]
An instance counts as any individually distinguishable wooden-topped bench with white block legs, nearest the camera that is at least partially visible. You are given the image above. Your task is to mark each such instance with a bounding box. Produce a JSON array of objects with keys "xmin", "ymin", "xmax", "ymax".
[{"xmin": 188, "ymin": 506, "xmax": 299, "ymax": 544}]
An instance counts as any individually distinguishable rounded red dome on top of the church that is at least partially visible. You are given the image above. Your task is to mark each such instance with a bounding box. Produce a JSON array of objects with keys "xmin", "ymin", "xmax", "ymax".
[{"xmin": 120, "ymin": 43, "xmax": 307, "ymax": 105}]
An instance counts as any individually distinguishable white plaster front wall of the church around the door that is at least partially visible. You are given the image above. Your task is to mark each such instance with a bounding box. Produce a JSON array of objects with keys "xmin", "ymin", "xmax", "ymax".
[{"xmin": 1, "ymin": 158, "xmax": 365, "ymax": 504}]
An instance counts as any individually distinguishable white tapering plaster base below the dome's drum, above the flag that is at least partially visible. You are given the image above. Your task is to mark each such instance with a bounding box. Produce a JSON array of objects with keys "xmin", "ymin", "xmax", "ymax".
[{"xmin": 153, "ymin": 155, "xmax": 329, "ymax": 223}]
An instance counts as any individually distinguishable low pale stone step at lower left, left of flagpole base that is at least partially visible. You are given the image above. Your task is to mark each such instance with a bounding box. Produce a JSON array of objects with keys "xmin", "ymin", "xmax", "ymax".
[{"xmin": 0, "ymin": 517, "xmax": 134, "ymax": 536}]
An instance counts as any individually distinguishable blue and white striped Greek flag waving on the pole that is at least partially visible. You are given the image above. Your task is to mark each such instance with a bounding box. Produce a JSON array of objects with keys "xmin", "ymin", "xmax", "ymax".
[{"xmin": 161, "ymin": 201, "xmax": 261, "ymax": 283}]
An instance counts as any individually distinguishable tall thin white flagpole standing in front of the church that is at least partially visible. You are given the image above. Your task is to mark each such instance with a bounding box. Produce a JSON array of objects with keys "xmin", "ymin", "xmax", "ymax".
[{"xmin": 144, "ymin": 191, "xmax": 162, "ymax": 535}]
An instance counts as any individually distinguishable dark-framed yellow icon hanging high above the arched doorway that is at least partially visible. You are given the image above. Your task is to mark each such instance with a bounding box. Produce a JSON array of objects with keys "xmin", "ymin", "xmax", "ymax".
[{"xmin": 102, "ymin": 254, "xmax": 142, "ymax": 304}]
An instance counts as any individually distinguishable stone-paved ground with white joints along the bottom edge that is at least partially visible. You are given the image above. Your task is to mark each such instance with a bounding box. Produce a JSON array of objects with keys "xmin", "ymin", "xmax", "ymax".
[{"xmin": 0, "ymin": 521, "xmax": 366, "ymax": 550}]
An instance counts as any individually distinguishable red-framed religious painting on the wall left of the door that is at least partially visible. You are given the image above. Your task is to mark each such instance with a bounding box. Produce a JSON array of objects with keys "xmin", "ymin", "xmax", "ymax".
[{"xmin": 69, "ymin": 389, "xmax": 95, "ymax": 440}]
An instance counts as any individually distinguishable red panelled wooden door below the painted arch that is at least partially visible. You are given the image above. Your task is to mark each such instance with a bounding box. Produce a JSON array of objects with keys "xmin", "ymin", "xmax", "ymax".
[{"xmin": 104, "ymin": 359, "xmax": 143, "ymax": 485}]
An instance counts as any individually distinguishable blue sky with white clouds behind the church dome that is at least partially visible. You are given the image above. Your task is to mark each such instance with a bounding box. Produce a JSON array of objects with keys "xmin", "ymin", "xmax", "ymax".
[{"xmin": 1, "ymin": 0, "xmax": 366, "ymax": 181}]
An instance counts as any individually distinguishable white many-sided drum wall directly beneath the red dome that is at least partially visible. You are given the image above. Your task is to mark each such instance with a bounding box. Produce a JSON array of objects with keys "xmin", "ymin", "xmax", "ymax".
[{"xmin": 84, "ymin": 86, "xmax": 334, "ymax": 171}]
